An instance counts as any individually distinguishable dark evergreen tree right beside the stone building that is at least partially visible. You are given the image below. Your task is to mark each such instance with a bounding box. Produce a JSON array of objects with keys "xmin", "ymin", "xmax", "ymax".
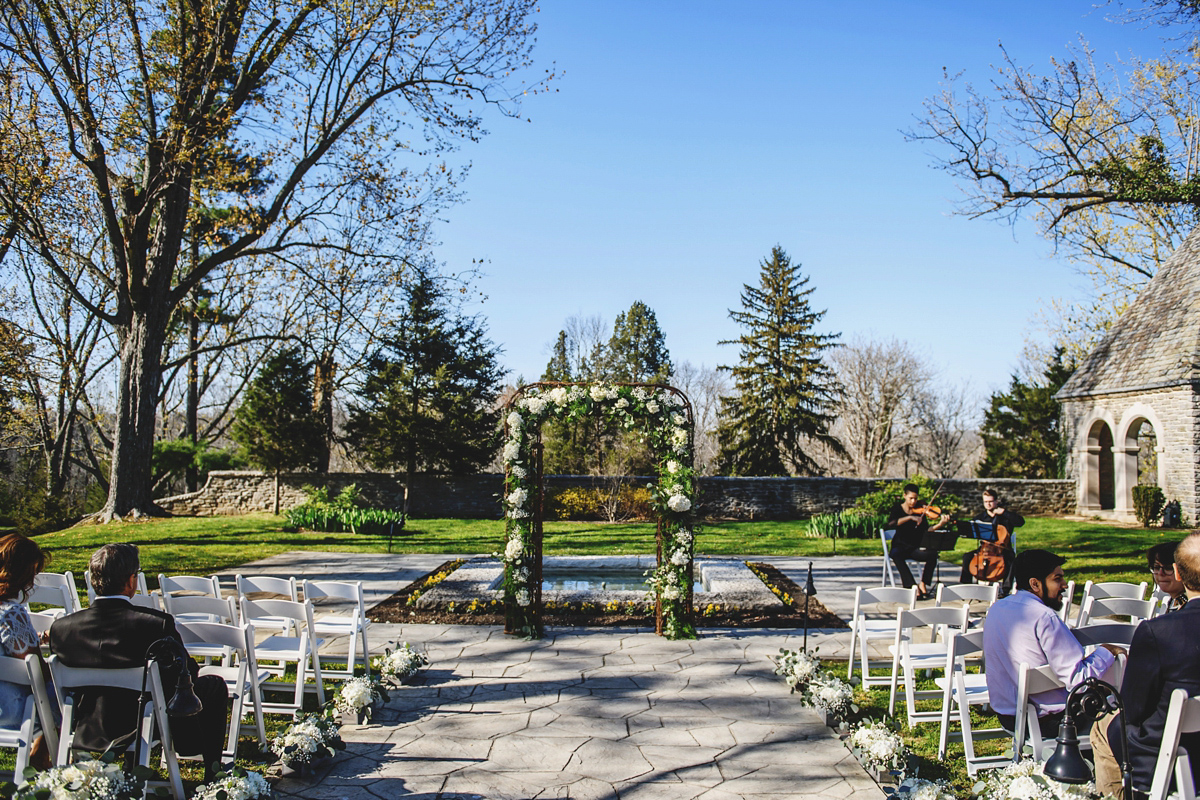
[{"xmin": 978, "ymin": 347, "xmax": 1075, "ymax": 479}]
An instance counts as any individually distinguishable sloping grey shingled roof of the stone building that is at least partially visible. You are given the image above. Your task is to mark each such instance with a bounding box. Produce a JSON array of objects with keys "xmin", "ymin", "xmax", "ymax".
[{"xmin": 1056, "ymin": 228, "xmax": 1200, "ymax": 401}]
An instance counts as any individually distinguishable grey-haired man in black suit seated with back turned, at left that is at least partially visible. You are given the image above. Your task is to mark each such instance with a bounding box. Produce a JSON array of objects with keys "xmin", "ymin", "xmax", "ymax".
[{"xmin": 50, "ymin": 543, "xmax": 229, "ymax": 780}]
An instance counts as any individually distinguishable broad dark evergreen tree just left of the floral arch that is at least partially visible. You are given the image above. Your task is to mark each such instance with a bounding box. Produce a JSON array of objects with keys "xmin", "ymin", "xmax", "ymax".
[{"xmin": 347, "ymin": 273, "xmax": 504, "ymax": 494}]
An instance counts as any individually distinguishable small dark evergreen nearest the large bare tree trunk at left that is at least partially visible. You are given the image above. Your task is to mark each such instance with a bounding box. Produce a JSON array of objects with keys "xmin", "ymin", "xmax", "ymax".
[{"xmin": 230, "ymin": 347, "xmax": 324, "ymax": 474}]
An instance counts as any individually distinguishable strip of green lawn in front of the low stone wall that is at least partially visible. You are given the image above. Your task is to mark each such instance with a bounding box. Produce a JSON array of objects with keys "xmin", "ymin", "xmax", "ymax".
[{"xmin": 37, "ymin": 513, "xmax": 1183, "ymax": 594}]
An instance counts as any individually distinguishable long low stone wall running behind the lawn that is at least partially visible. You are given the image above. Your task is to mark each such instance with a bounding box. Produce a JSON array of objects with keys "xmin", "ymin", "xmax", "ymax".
[{"xmin": 158, "ymin": 471, "xmax": 1076, "ymax": 519}]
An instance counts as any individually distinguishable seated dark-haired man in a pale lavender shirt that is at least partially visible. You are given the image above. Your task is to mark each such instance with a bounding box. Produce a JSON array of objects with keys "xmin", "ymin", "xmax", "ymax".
[{"xmin": 983, "ymin": 549, "xmax": 1123, "ymax": 739}]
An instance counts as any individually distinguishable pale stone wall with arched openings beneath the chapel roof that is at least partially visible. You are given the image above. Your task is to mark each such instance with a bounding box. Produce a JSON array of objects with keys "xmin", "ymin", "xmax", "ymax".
[{"xmin": 1062, "ymin": 385, "xmax": 1200, "ymax": 521}]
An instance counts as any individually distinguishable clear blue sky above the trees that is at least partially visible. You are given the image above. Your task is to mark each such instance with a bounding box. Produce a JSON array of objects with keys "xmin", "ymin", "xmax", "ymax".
[{"xmin": 436, "ymin": 0, "xmax": 1163, "ymax": 395}]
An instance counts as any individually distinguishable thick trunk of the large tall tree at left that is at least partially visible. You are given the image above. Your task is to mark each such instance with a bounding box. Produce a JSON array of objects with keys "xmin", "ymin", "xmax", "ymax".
[{"xmin": 97, "ymin": 300, "xmax": 170, "ymax": 522}]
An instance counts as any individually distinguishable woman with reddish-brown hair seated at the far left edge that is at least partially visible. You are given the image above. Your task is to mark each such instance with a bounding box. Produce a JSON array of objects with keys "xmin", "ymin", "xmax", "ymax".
[{"xmin": 0, "ymin": 534, "xmax": 49, "ymax": 768}]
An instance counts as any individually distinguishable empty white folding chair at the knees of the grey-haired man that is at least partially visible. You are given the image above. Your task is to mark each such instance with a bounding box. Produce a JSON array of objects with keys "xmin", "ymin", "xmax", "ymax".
[{"xmin": 179, "ymin": 623, "xmax": 271, "ymax": 759}]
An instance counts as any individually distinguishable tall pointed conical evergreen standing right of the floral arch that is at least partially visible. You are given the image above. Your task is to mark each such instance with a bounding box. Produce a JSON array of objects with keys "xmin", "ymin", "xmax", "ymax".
[{"xmin": 718, "ymin": 246, "xmax": 841, "ymax": 475}]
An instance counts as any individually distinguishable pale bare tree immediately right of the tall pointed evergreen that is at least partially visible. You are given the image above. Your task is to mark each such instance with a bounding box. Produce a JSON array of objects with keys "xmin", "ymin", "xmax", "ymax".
[{"xmin": 830, "ymin": 337, "xmax": 932, "ymax": 477}]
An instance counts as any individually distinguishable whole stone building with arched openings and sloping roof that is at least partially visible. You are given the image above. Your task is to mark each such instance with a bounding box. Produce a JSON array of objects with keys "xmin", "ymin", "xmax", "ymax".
[{"xmin": 1057, "ymin": 229, "xmax": 1200, "ymax": 522}]
